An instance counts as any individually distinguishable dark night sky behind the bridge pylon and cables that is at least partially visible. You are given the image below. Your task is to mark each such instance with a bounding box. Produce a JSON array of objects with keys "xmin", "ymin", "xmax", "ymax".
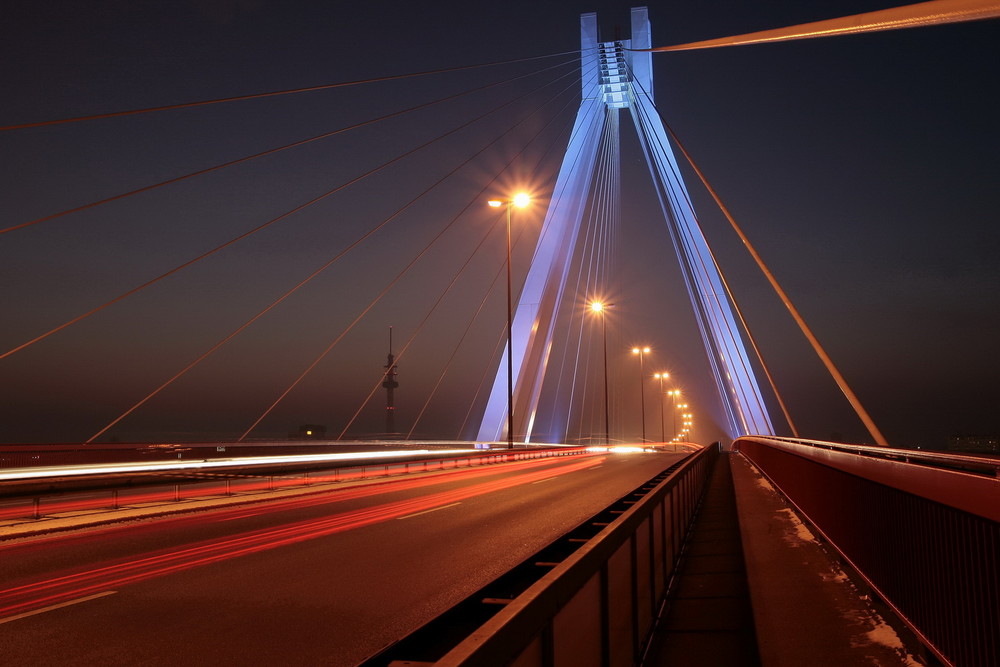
[{"xmin": 0, "ymin": 0, "xmax": 1000, "ymax": 447}]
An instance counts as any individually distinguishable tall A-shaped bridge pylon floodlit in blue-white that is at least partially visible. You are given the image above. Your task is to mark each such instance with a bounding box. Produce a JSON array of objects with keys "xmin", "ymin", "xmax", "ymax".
[{"xmin": 477, "ymin": 7, "xmax": 773, "ymax": 442}]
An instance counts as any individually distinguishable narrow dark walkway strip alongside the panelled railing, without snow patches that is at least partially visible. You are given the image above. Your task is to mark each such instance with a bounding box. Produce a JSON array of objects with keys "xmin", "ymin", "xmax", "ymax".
[{"xmin": 644, "ymin": 452, "xmax": 760, "ymax": 667}]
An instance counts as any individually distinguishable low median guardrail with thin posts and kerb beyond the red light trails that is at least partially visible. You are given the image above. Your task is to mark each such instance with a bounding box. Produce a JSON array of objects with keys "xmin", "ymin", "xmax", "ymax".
[{"xmin": 0, "ymin": 447, "xmax": 586, "ymax": 522}]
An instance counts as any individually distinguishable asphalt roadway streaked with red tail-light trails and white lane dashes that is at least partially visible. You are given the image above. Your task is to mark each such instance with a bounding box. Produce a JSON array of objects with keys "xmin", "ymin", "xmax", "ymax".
[{"xmin": 0, "ymin": 453, "xmax": 681, "ymax": 667}]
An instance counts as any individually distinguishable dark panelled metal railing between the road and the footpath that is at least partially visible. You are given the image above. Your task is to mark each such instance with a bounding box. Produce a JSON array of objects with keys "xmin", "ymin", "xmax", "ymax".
[{"xmin": 363, "ymin": 445, "xmax": 719, "ymax": 667}]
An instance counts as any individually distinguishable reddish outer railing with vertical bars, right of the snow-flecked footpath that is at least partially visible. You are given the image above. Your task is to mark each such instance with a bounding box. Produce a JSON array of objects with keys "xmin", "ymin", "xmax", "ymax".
[{"xmin": 733, "ymin": 437, "xmax": 1000, "ymax": 666}]
